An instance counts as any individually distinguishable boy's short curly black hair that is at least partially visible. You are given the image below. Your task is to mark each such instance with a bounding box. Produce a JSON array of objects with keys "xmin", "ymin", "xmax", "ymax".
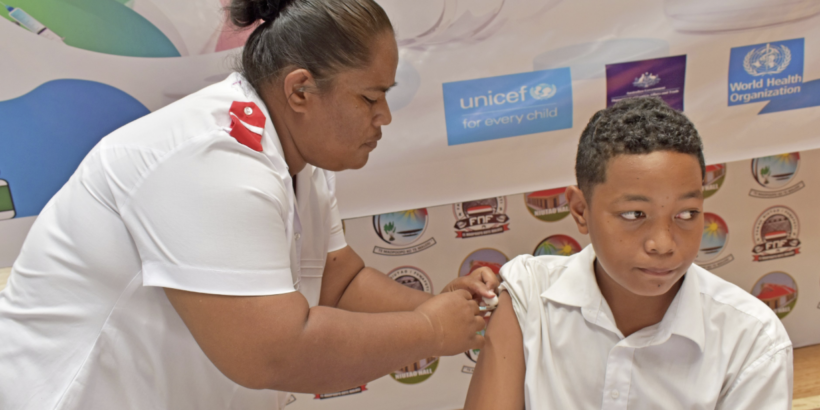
[{"xmin": 575, "ymin": 97, "xmax": 706, "ymax": 199}]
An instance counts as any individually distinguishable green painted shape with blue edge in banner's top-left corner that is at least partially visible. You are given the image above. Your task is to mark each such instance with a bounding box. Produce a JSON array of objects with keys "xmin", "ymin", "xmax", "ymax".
[{"xmin": 0, "ymin": 0, "xmax": 180, "ymax": 57}]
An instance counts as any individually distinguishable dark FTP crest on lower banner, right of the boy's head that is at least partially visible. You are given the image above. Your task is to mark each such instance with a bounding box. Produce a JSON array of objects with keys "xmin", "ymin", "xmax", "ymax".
[{"xmin": 752, "ymin": 206, "xmax": 800, "ymax": 262}]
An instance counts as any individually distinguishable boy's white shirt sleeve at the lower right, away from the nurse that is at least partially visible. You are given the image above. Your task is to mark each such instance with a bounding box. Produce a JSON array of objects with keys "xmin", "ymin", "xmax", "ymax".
[{"xmin": 716, "ymin": 345, "xmax": 794, "ymax": 410}]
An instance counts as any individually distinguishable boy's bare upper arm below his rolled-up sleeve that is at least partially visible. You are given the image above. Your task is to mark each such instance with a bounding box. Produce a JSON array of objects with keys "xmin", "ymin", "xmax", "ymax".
[{"xmin": 464, "ymin": 291, "xmax": 526, "ymax": 410}]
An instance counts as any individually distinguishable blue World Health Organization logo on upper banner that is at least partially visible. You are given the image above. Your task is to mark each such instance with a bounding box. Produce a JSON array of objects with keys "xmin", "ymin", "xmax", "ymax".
[{"xmin": 729, "ymin": 38, "xmax": 804, "ymax": 106}]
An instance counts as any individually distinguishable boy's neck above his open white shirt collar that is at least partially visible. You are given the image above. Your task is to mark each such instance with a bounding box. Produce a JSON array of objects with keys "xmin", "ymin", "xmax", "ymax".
[{"xmin": 594, "ymin": 259, "xmax": 686, "ymax": 337}]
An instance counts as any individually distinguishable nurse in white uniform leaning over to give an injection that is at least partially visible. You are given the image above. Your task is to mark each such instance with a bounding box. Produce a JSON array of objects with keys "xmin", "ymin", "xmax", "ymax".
[{"xmin": 0, "ymin": 0, "xmax": 498, "ymax": 410}]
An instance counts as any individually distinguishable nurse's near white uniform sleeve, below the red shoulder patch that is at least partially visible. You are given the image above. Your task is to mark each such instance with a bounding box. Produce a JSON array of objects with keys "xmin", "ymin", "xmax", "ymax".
[{"xmin": 120, "ymin": 135, "xmax": 294, "ymax": 296}]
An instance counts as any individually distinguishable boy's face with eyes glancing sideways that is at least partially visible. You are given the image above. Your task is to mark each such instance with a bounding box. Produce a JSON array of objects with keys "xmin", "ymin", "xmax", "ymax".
[{"xmin": 567, "ymin": 151, "xmax": 703, "ymax": 296}]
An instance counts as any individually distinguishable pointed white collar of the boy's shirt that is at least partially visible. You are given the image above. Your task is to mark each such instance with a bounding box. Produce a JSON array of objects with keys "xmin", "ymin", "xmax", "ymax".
[{"xmin": 541, "ymin": 245, "xmax": 705, "ymax": 351}]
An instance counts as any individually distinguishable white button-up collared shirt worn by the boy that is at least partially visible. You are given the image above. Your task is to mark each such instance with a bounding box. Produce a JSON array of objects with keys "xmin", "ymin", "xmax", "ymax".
[{"xmin": 501, "ymin": 245, "xmax": 792, "ymax": 410}]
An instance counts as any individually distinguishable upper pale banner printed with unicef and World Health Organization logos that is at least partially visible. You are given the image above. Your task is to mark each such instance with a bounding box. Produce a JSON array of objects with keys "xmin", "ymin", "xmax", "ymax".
[{"xmin": 0, "ymin": 0, "xmax": 820, "ymax": 266}]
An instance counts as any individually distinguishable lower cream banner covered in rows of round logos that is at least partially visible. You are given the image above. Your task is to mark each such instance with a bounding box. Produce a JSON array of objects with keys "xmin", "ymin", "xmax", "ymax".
[{"xmin": 288, "ymin": 150, "xmax": 820, "ymax": 410}]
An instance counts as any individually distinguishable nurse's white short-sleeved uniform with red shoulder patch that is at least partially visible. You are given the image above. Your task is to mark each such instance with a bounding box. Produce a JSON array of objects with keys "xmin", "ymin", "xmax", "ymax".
[{"xmin": 0, "ymin": 74, "xmax": 346, "ymax": 410}]
